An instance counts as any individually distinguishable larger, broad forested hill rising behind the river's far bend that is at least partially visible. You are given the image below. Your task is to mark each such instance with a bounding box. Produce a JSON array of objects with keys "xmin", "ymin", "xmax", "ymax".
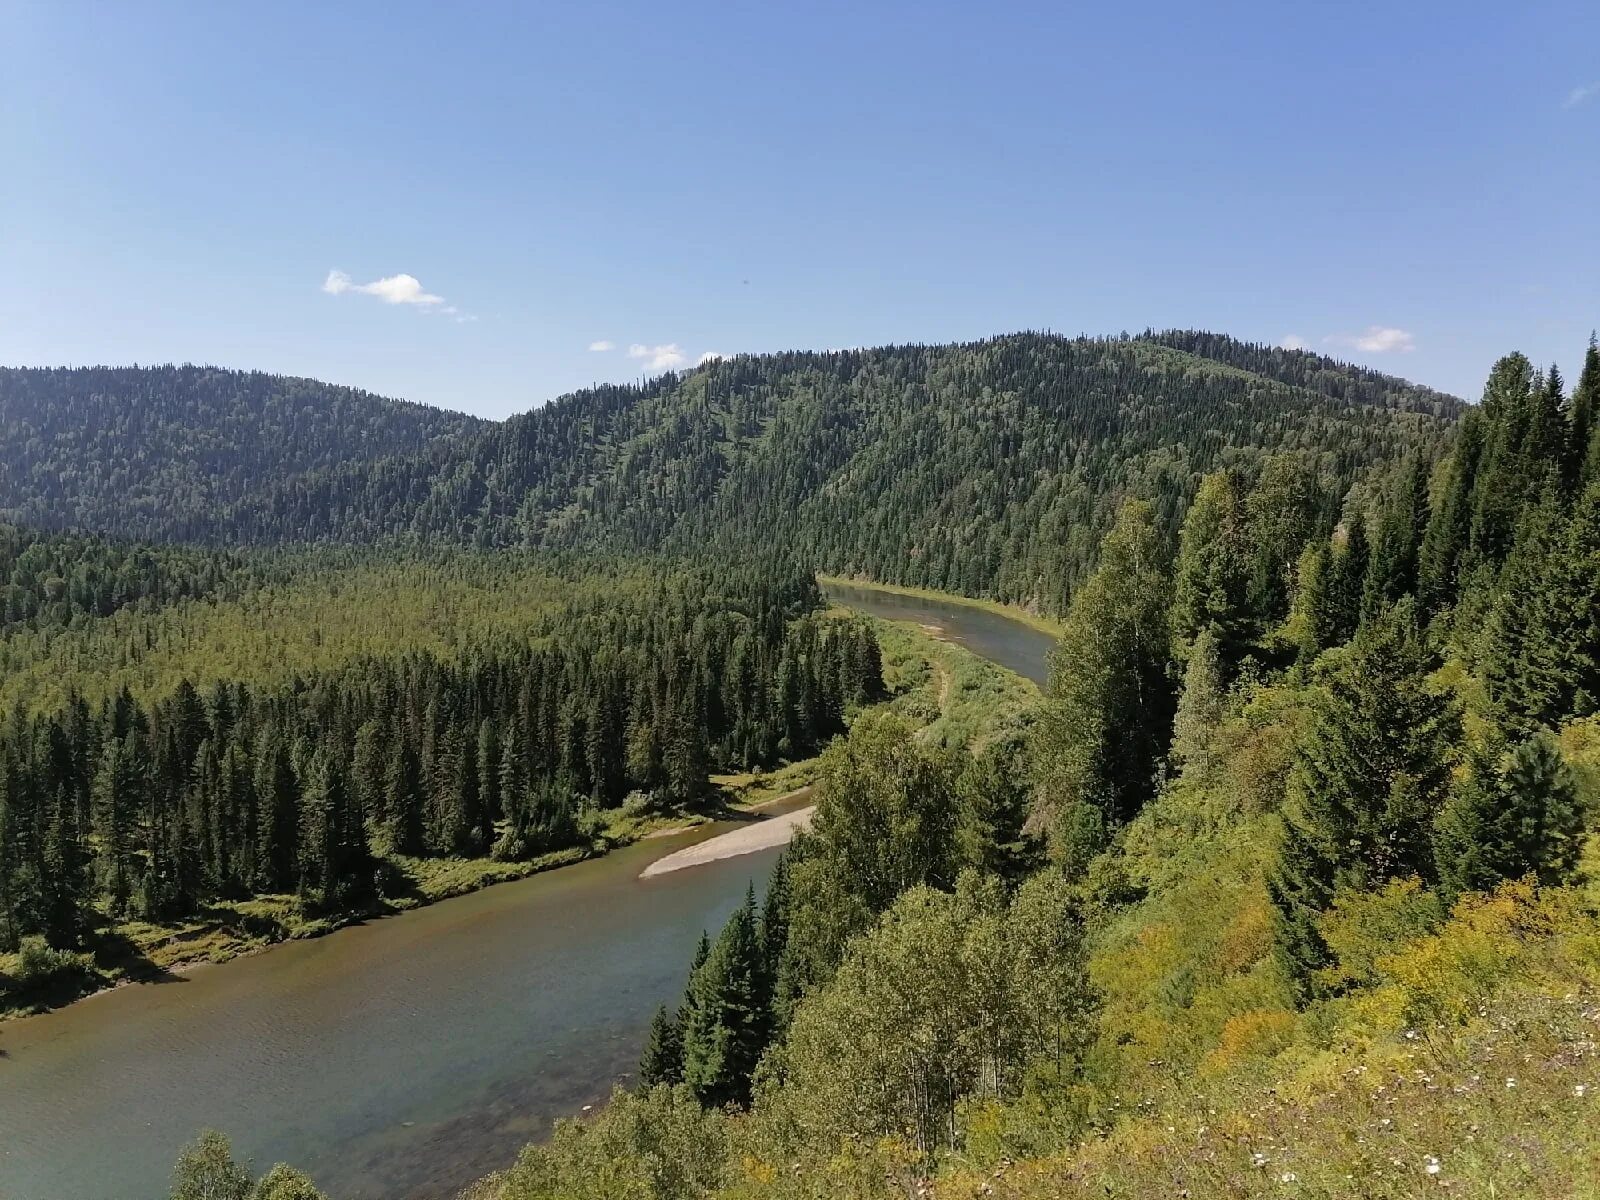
[{"xmin": 178, "ymin": 333, "xmax": 1461, "ymax": 608}]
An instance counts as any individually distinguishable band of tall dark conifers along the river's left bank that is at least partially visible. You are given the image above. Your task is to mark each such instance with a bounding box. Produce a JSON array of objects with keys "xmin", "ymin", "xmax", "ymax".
[{"xmin": 0, "ymin": 573, "xmax": 883, "ymax": 949}]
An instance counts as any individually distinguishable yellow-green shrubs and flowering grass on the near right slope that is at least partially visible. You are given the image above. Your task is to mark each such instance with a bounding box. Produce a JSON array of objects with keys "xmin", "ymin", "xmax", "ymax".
[{"xmin": 933, "ymin": 686, "xmax": 1600, "ymax": 1200}]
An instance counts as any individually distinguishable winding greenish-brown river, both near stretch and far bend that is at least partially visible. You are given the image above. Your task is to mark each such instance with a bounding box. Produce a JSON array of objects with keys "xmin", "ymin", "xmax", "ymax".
[{"xmin": 0, "ymin": 587, "xmax": 1051, "ymax": 1200}]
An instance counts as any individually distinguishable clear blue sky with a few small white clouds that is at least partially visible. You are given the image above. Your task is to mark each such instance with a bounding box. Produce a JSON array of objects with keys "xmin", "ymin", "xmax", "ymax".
[{"xmin": 0, "ymin": 0, "xmax": 1600, "ymax": 416}]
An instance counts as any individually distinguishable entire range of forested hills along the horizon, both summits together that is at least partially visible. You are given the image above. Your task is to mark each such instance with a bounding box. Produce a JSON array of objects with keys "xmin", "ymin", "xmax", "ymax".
[{"xmin": 0, "ymin": 333, "xmax": 1461, "ymax": 608}]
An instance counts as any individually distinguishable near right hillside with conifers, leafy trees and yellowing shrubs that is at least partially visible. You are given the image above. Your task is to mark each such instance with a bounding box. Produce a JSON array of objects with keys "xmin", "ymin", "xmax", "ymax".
[{"xmin": 474, "ymin": 339, "xmax": 1600, "ymax": 1200}]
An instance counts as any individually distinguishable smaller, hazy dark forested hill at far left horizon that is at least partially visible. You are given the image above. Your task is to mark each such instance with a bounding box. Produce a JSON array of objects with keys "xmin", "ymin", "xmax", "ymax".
[{"xmin": 0, "ymin": 366, "xmax": 485, "ymax": 538}]
